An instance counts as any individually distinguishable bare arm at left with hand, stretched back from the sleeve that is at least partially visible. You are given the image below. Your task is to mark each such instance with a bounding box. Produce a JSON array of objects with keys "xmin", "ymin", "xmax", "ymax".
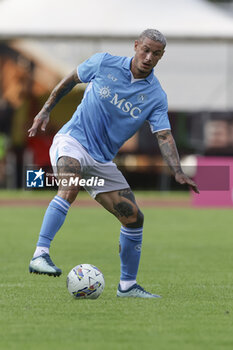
[{"xmin": 28, "ymin": 70, "xmax": 81, "ymax": 137}]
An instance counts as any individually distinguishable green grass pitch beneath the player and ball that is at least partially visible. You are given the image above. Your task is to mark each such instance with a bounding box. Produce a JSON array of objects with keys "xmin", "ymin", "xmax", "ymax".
[{"xmin": 0, "ymin": 193, "xmax": 233, "ymax": 350}]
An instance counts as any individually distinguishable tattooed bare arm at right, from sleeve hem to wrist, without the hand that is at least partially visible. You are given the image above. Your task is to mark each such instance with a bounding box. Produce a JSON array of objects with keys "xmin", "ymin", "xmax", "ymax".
[{"xmin": 156, "ymin": 130, "xmax": 182, "ymax": 174}]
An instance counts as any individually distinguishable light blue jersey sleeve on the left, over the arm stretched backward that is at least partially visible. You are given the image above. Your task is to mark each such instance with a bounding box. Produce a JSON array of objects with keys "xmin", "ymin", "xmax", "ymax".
[{"xmin": 77, "ymin": 53, "xmax": 105, "ymax": 83}]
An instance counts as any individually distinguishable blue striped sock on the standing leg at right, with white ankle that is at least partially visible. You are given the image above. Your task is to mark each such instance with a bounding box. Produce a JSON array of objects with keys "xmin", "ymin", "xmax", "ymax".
[{"xmin": 120, "ymin": 226, "xmax": 143, "ymax": 290}]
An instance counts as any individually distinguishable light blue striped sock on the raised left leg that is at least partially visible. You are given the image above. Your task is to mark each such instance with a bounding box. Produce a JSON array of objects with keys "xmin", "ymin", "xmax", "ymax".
[{"xmin": 34, "ymin": 196, "xmax": 70, "ymax": 255}]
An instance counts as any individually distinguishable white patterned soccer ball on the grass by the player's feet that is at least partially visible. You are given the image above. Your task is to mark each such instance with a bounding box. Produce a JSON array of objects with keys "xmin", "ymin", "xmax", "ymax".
[{"xmin": 66, "ymin": 264, "xmax": 105, "ymax": 299}]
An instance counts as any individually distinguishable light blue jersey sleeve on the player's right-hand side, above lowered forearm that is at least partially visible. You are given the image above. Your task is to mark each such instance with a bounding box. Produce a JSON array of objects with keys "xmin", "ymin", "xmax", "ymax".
[{"xmin": 147, "ymin": 92, "xmax": 171, "ymax": 133}]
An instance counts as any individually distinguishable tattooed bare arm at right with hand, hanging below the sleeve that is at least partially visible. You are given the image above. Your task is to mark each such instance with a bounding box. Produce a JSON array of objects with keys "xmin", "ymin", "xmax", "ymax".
[{"xmin": 156, "ymin": 130, "xmax": 199, "ymax": 193}]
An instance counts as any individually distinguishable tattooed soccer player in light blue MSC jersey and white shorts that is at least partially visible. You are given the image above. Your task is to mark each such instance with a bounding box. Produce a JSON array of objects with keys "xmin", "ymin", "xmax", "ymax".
[{"xmin": 29, "ymin": 29, "xmax": 198, "ymax": 298}]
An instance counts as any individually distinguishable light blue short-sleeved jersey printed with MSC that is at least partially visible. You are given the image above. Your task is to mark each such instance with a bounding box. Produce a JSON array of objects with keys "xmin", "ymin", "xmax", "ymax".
[{"xmin": 59, "ymin": 53, "xmax": 170, "ymax": 163}]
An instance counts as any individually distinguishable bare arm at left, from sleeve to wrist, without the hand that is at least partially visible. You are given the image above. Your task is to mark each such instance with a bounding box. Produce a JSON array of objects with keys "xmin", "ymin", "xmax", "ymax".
[{"xmin": 43, "ymin": 71, "xmax": 81, "ymax": 112}]
